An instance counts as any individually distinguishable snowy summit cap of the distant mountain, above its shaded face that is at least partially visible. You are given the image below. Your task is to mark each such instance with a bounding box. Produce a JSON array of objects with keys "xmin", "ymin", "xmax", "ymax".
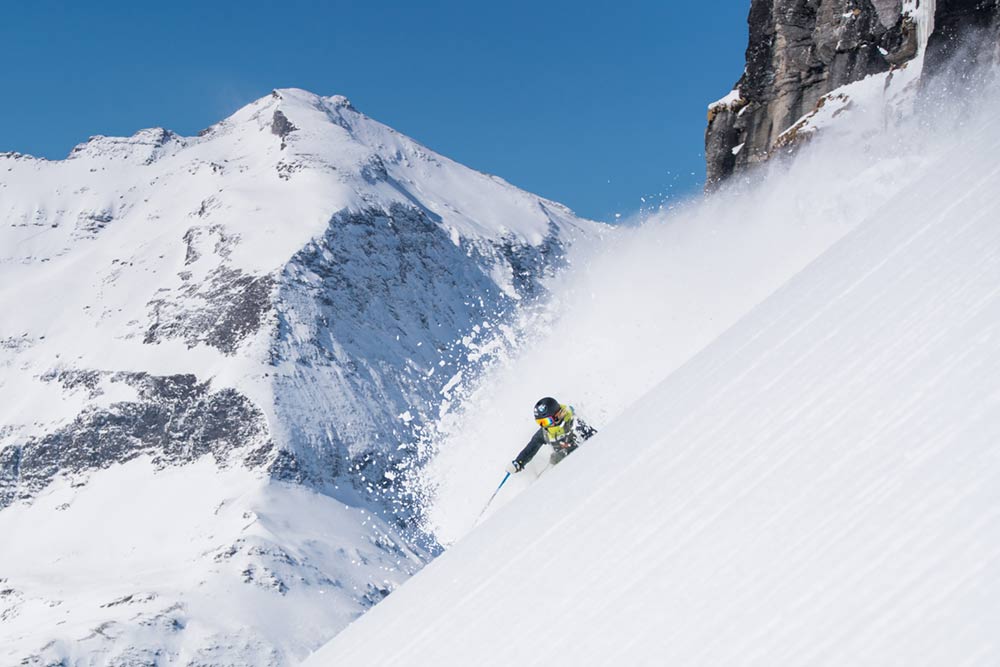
[{"xmin": 188, "ymin": 88, "xmax": 573, "ymax": 244}]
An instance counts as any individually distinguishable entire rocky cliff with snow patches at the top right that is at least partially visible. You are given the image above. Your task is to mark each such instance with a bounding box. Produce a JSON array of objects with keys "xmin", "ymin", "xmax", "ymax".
[{"xmin": 705, "ymin": 0, "xmax": 998, "ymax": 189}]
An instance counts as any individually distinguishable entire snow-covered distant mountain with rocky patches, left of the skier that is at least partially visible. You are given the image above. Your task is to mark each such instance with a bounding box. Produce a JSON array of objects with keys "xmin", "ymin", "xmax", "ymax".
[{"xmin": 0, "ymin": 90, "xmax": 602, "ymax": 665}]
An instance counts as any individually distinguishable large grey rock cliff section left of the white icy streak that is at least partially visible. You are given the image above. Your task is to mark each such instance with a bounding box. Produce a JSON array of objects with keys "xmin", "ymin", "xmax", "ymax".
[{"xmin": 705, "ymin": 0, "xmax": 917, "ymax": 189}]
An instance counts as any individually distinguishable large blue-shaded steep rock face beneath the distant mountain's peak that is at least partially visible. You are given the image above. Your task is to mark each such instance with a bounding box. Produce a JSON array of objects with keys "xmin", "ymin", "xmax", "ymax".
[{"xmin": 270, "ymin": 204, "xmax": 565, "ymax": 503}]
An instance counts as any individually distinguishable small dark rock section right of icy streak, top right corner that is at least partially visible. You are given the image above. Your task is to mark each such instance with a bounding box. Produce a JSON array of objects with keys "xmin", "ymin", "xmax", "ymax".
[{"xmin": 924, "ymin": 0, "xmax": 1000, "ymax": 77}]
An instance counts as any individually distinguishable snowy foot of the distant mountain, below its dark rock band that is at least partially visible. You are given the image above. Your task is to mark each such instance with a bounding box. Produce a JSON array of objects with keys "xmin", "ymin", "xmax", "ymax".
[{"xmin": 0, "ymin": 457, "xmax": 426, "ymax": 667}]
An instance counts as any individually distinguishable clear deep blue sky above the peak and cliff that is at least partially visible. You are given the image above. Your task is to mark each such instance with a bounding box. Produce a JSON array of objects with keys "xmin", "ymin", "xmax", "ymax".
[{"xmin": 0, "ymin": 0, "xmax": 750, "ymax": 219}]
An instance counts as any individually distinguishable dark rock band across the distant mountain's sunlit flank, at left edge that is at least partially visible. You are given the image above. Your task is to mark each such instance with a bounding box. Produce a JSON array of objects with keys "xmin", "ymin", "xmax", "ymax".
[{"xmin": 0, "ymin": 371, "xmax": 271, "ymax": 509}]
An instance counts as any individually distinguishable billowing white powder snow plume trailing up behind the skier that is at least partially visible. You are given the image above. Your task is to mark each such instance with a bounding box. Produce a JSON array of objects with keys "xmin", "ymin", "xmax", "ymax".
[{"xmin": 421, "ymin": 58, "xmax": 995, "ymax": 544}]
